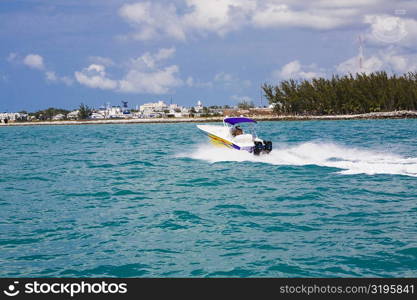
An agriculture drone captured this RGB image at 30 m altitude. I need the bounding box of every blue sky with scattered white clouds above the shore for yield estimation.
[0,0,417,112]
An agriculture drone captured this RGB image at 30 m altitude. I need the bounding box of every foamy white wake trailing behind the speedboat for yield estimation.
[181,142,417,177]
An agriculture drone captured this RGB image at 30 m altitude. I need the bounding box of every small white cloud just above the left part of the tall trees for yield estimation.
[272,60,325,80]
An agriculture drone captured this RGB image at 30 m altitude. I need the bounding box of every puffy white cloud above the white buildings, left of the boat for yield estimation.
[75,48,184,94]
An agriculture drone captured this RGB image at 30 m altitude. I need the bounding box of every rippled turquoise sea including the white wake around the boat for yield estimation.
[0,120,417,277]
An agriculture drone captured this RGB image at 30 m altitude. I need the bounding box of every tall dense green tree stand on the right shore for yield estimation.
[262,72,417,115]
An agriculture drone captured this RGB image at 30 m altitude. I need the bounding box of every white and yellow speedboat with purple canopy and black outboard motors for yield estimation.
[197,117,272,155]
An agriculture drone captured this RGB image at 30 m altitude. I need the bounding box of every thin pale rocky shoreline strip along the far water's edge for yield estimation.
[0,110,417,127]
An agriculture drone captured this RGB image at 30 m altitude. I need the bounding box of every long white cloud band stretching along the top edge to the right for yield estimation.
[119,0,417,41]
